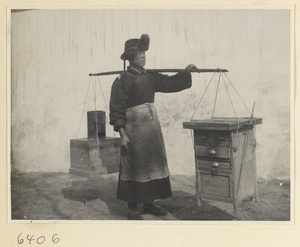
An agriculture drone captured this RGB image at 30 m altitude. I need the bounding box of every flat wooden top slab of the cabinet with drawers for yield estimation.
[183,117,262,131]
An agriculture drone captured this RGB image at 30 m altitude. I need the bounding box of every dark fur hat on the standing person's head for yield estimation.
[121,34,150,61]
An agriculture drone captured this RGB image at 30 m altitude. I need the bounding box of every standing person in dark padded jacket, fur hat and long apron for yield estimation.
[110,34,196,220]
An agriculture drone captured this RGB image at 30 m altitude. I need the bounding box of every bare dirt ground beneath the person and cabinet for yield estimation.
[11,173,290,221]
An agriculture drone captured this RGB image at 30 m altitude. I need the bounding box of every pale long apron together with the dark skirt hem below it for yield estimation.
[117,103,171,203]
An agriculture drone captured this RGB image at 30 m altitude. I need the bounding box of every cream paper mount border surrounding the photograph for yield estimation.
[0,1,299,246]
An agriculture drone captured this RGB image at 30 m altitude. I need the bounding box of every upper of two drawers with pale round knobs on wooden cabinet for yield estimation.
[195,146,230,159]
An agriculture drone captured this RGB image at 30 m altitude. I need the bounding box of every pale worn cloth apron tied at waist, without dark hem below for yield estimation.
[120,103,169,182]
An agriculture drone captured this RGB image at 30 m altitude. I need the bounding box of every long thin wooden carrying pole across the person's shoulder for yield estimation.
[89,69,228,76]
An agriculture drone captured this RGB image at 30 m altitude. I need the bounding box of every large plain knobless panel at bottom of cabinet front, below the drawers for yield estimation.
[199,172,232,198]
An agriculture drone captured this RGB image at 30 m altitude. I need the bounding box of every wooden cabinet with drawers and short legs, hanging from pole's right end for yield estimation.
[183,118,262,212]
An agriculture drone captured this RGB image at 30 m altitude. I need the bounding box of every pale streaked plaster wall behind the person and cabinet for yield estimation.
[11,9,291,178]
